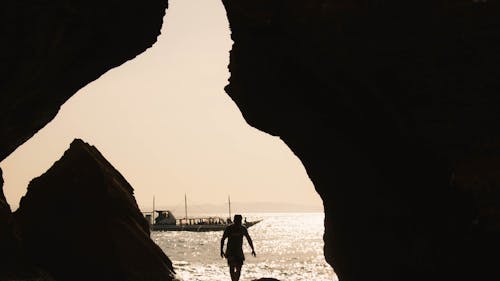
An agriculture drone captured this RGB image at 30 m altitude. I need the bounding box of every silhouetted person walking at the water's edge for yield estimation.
[220,215,255,281]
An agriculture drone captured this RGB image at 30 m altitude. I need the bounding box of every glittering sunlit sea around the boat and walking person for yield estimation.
[151,213,338,281]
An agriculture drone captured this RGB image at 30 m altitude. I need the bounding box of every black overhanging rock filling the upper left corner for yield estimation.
[0,0,168,160]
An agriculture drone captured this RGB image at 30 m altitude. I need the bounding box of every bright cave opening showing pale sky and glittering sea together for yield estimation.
[0,0,335,280]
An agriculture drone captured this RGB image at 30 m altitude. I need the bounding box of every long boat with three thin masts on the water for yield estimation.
[146,195,262,232]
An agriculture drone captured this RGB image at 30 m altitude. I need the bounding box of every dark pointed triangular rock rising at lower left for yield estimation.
[15,139,173,281]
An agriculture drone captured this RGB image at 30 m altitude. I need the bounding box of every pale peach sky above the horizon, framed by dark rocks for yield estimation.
[0,0,322,210]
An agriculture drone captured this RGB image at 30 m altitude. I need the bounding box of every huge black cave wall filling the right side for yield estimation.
[222,0,500,280]
